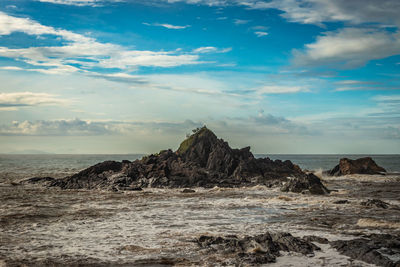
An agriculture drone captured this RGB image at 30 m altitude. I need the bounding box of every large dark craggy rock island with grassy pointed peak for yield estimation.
[39,127,329,194]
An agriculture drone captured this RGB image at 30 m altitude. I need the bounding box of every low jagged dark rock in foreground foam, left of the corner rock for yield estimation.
[196,232,319,265]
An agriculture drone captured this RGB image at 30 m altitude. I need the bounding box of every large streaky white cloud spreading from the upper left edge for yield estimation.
[0,12,203,74]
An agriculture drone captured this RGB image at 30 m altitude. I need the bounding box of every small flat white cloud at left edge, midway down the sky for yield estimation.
[0,92,67,109]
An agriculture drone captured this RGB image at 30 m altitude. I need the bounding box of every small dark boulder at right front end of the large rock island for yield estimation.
[281,173,330,195]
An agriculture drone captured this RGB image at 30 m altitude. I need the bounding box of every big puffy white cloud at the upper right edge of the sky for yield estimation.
[293,28,400,68]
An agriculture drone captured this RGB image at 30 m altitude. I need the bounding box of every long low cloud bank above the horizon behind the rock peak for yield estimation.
[0,115,311,136]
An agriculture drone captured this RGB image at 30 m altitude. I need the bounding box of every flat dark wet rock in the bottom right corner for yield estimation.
[331,234,400,267]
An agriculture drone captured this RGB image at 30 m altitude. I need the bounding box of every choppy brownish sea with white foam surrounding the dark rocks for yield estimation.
[0,154,400,267]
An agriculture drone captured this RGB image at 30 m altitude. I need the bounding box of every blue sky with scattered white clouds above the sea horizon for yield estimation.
[0,0,400,154]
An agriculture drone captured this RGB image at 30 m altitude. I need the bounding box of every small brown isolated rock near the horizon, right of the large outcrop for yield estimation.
[328,157,386,176]
